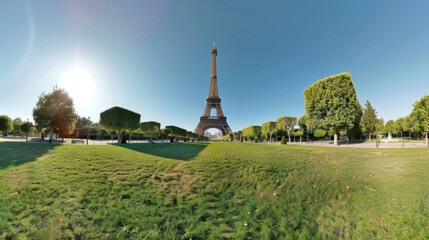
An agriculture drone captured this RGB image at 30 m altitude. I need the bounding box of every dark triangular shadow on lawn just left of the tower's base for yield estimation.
[115,143,209,161]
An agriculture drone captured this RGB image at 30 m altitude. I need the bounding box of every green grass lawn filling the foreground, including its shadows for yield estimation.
[0,142,429,239]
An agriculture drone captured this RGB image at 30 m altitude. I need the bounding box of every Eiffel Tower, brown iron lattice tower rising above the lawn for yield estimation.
[194,46,232,135]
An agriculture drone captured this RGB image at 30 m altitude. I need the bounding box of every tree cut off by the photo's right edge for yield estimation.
[411,95,429,147]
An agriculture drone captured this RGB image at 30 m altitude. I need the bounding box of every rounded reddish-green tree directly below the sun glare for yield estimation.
[33,87,77,142]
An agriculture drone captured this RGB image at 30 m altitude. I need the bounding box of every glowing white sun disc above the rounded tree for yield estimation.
[61,66,94,102]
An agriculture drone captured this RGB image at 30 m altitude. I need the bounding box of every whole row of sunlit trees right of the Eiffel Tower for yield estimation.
[231,73,429,146]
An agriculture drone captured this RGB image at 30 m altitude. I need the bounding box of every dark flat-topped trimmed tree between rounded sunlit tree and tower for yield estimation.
[100,106,140,143]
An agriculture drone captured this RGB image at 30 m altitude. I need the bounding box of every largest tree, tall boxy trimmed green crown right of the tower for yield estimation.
[304,73,362,146]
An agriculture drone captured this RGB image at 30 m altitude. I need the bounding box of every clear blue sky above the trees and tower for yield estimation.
[0,0,429,131]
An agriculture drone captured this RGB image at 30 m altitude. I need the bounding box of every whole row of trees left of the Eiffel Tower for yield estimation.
[0,87,200,143]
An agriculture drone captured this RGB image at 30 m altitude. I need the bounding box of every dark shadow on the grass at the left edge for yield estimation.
[0,142,58,170]
